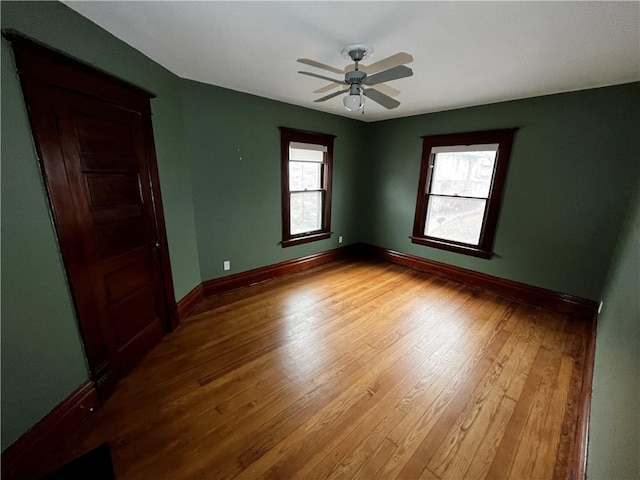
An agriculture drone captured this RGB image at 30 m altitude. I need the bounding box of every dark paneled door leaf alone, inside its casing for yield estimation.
[47,87,168,380]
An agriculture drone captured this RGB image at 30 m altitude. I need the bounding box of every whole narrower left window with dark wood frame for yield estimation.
[280,127,335,247]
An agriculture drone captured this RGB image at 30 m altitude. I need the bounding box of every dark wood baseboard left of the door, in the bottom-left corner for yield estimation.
[2,381,100,480]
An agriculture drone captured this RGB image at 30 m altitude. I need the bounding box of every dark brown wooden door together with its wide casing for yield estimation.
[8,31,175,395]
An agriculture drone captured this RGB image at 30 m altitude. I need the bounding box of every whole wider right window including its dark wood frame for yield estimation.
[411,129,515,258]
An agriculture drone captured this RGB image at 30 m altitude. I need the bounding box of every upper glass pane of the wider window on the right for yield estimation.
[431,150,496,198]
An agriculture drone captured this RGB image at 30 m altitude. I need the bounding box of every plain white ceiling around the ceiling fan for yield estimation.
[65,1,640,121]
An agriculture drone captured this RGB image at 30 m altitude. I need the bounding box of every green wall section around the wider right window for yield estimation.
[362,83,640,300]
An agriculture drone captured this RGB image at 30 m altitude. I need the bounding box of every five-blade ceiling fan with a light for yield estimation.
[298,45,413,112]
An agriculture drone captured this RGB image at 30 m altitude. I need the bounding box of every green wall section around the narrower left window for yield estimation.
[182,80,366,280]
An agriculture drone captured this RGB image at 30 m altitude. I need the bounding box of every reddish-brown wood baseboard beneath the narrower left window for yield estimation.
[202,244,362,297]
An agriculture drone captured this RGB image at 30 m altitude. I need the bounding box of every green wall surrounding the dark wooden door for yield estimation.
[0,1,201,449]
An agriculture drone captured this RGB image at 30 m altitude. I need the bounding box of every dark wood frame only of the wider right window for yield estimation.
[410,128,517,259]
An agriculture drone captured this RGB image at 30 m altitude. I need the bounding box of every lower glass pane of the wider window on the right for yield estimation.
[424,196,487,245]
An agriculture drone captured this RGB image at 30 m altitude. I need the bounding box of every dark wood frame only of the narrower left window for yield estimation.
[280,127,336,247]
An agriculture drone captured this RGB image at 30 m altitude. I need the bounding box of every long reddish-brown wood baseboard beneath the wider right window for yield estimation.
[364,245,598,321]
